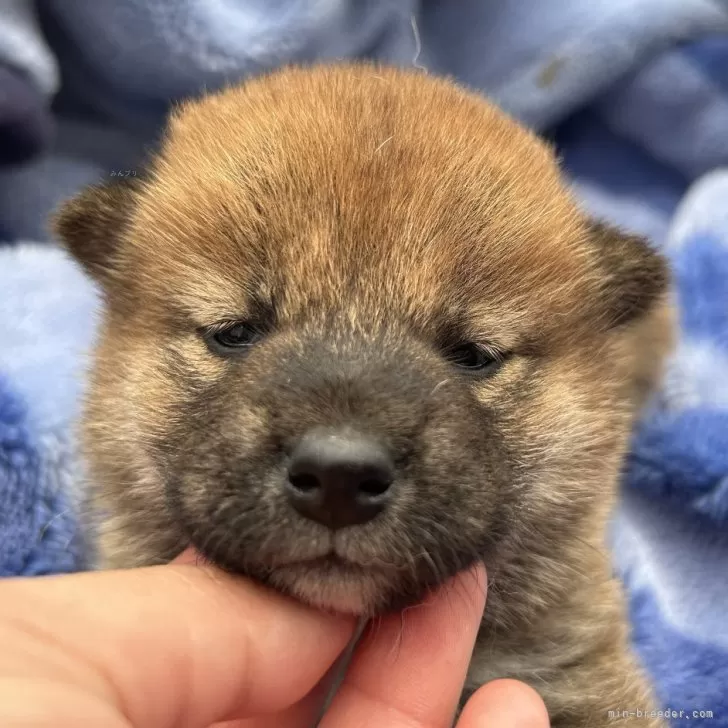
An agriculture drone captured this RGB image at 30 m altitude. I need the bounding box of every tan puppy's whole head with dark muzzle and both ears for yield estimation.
[57,66,666,613]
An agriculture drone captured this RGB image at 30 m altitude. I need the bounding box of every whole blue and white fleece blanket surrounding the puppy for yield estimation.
[0,0,728,727]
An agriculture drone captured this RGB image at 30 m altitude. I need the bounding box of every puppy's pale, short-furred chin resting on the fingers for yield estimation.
[268,564,393,617]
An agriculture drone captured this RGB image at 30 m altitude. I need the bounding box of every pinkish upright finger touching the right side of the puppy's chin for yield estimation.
[321,565,486,728]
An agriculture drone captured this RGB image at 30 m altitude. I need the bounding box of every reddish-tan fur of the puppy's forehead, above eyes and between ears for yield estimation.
[129,65,590,343]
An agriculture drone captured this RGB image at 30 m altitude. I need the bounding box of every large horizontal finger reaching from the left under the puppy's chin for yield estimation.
[0,565,353,728]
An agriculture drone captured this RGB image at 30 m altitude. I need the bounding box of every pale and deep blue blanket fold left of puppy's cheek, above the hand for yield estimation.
[0,245,98,576]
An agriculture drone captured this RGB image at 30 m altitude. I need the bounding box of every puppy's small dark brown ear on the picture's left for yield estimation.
[52,177,139,286]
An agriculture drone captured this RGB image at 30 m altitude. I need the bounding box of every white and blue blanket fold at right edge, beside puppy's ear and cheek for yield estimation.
[628,168,728,524]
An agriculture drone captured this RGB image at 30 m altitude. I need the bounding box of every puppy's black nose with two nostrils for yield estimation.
[287,430,394,529]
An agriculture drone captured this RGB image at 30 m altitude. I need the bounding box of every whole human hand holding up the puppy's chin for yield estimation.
[0,552,548,728]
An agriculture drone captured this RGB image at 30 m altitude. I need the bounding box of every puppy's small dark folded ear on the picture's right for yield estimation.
[589,222,670,328]
